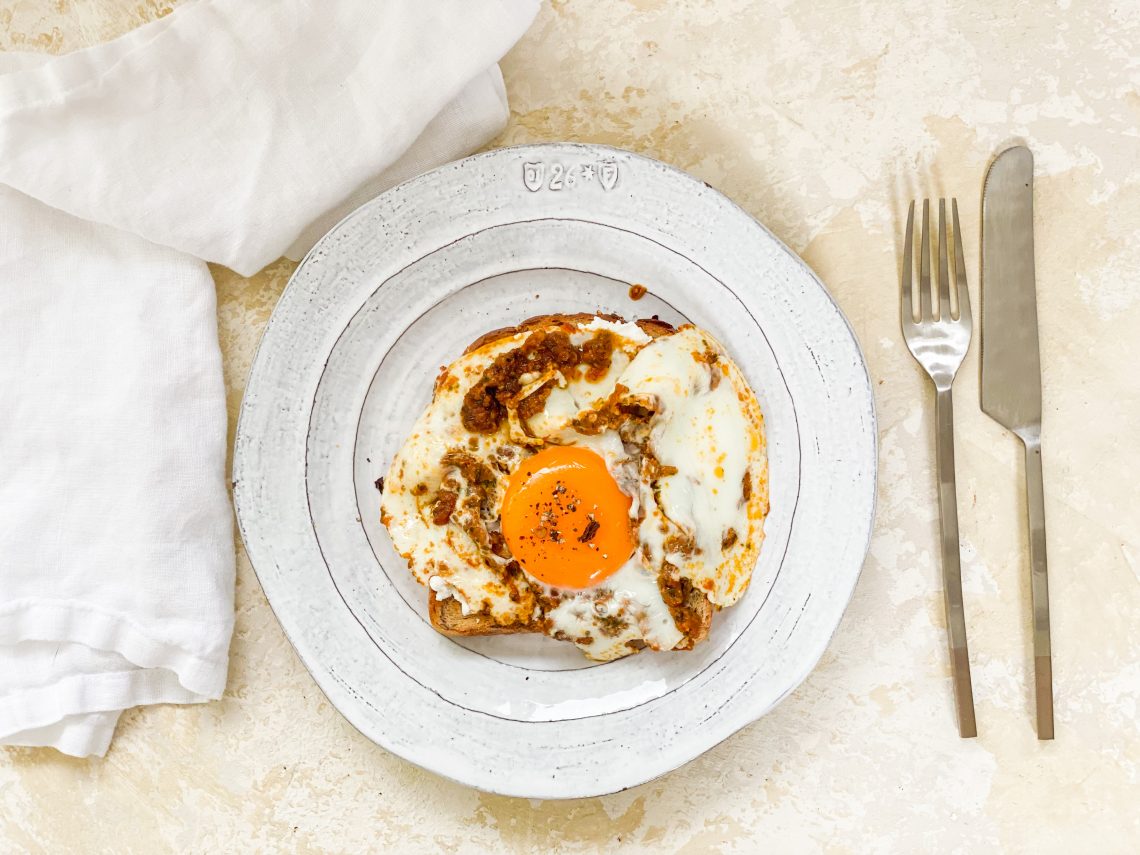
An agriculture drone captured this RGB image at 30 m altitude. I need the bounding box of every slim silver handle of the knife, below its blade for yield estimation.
[1023,434,1053,739]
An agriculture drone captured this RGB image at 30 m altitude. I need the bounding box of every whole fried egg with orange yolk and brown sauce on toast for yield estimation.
[382,315,767,660]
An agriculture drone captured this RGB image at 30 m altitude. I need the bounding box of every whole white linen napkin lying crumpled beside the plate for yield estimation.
[0,0,537,756]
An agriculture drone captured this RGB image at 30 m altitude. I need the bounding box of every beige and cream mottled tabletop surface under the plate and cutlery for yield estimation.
[0,0,1140,853]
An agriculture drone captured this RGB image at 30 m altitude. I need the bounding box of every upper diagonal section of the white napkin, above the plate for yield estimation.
[0,0,537,276]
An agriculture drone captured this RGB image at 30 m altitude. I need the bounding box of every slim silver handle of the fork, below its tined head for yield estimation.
[935,385,978,738]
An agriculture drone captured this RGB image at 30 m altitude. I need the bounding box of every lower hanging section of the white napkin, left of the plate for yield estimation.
[0,186,234,756]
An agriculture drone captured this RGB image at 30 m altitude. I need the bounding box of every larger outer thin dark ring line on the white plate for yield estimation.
[304,217,807,725]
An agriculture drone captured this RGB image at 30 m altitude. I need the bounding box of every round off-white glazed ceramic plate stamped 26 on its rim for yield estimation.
[234,144,876,798]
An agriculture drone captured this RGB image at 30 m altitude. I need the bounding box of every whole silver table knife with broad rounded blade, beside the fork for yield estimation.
[982,146,1053,739]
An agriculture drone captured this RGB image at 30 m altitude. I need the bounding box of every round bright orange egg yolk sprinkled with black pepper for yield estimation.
[502,446,634,588]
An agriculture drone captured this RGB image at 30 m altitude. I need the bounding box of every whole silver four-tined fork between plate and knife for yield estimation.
[899,200,978,738]
